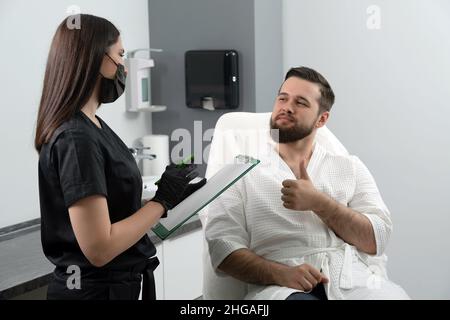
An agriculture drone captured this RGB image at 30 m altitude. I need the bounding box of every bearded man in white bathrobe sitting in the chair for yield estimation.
[205,67,408,300]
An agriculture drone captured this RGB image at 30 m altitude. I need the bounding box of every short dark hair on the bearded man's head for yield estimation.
[284,67,334,114]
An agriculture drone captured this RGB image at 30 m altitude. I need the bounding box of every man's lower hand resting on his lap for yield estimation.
[277,263,329,292]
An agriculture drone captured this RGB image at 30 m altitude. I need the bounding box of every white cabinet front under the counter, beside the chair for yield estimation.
[157,229,203,300]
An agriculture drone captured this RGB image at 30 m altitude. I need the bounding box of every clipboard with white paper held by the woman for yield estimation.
[152,155,260,240]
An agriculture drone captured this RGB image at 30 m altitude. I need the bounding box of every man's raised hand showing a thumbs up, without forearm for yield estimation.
[281,159,324,211]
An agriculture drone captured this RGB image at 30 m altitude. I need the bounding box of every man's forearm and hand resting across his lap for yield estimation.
[218,249,328,291]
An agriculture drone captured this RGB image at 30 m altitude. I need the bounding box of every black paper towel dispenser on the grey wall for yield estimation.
[184,50,239,110]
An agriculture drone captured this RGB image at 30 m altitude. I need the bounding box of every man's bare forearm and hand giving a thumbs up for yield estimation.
[281,160,377,254]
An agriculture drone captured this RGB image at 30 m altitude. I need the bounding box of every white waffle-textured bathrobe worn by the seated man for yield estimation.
[205,143,408,299]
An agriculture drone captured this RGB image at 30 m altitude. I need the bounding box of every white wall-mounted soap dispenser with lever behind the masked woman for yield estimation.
[125,48,166,112]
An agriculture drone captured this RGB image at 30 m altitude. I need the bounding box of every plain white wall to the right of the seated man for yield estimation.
[282,0,450,299]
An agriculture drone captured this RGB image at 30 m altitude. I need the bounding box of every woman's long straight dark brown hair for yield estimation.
[34,14,120,152]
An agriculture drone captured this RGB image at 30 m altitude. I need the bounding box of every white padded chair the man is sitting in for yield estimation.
[200,112,348,300]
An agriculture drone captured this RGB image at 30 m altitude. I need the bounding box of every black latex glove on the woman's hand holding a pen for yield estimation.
[151,164,206,218]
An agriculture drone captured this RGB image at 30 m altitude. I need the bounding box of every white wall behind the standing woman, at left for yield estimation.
[0,0,151,228]
